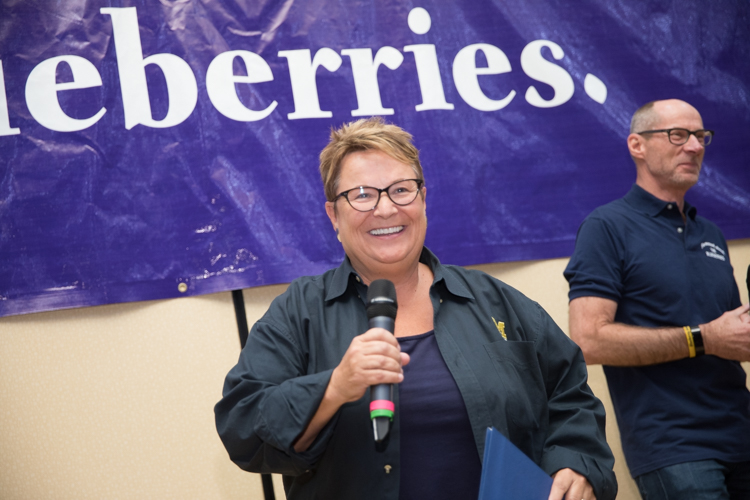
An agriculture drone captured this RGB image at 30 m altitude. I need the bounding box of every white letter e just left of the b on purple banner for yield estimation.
[26,55,107,132]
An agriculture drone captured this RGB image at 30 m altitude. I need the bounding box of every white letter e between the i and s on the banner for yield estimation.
[453,43,516,111]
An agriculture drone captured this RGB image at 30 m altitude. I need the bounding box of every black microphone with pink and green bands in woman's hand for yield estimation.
[367,280,398,445]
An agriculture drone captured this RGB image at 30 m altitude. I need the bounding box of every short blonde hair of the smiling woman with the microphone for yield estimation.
[320,117,424,201]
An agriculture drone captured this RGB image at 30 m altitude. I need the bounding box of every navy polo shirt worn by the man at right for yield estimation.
[565,185,750,477]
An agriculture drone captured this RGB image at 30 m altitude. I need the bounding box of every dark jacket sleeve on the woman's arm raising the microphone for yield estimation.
[214,295,337,476]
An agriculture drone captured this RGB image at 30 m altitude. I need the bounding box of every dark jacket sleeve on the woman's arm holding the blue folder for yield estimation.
[537,307,617,500]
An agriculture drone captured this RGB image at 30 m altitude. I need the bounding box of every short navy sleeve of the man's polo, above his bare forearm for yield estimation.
[563,217,624,302]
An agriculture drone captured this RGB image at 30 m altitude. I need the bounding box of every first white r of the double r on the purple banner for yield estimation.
[279,47,341,120]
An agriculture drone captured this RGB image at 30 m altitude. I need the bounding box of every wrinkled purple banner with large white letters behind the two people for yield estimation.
[0,0,750,316]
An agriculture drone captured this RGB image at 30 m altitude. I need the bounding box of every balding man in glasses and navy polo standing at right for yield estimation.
[565,100,750,500]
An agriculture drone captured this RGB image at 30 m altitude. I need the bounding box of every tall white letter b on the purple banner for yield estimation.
[99,7,198,130]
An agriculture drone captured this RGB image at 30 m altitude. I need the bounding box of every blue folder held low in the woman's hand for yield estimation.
[479,427,552,500]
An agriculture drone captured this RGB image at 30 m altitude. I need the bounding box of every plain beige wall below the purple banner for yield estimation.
[0,240,750,500]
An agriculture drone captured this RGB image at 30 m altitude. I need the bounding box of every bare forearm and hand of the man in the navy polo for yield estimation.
[570,297,750,366]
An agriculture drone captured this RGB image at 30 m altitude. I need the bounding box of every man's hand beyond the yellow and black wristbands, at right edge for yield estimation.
[700,304,750,361]
